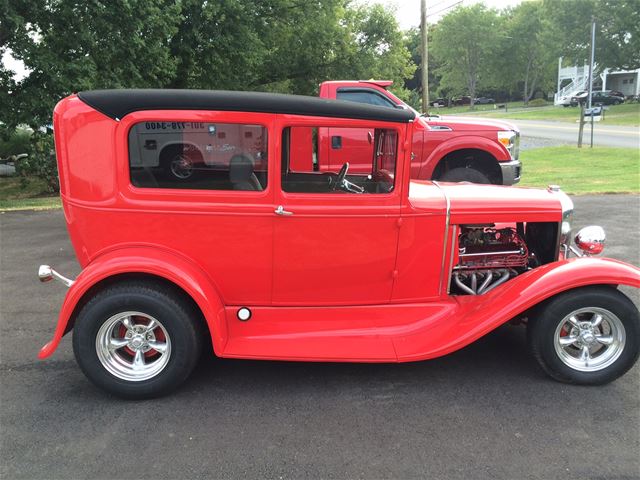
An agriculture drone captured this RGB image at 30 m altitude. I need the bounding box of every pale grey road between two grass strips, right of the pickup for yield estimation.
[507,119,640,148]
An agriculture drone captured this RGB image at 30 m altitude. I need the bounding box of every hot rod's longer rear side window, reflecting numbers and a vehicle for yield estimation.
[129,121,268,191]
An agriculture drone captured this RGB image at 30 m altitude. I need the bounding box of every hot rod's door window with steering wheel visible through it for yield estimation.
[282,126,398,194]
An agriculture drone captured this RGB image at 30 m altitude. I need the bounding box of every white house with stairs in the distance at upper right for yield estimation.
[554,58,640,105]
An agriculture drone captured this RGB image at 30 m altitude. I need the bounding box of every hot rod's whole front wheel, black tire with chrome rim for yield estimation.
[527,286,640,385]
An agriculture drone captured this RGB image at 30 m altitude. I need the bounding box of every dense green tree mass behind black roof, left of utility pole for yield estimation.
[0,0,415,129]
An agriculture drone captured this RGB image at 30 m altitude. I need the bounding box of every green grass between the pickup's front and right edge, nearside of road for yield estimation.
[518,146,640,194]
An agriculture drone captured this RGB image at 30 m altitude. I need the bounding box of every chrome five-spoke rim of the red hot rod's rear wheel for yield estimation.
[96,311,171,382]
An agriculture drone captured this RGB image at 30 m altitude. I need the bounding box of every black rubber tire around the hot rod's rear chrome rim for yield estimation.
[73,281,203,399]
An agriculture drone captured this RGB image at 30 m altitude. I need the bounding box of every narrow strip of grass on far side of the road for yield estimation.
[444,103,640,126]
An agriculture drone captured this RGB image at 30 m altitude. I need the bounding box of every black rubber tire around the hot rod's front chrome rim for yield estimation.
[527,286,640,385]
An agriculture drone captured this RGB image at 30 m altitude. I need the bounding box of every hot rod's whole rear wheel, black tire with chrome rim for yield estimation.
[73,282,202,399]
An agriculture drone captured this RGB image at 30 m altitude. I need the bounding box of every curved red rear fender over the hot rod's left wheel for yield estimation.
[38,246,227,359]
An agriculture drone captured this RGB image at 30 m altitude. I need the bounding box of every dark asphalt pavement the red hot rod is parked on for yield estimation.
[0,196,640,480]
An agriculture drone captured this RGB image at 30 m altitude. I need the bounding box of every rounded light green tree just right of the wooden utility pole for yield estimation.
[430,4,503,106]
